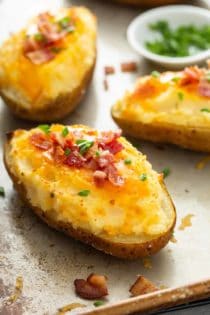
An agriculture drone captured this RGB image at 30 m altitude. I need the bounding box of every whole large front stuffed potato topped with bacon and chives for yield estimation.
[4,124,176,259]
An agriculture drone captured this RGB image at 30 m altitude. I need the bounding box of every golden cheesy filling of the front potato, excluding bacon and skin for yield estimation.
[6,125,174,241]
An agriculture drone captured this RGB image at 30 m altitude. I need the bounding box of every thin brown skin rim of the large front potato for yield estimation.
[4,132,176,260]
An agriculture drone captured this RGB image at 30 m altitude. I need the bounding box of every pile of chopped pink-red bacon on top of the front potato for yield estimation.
[30,130,124,186]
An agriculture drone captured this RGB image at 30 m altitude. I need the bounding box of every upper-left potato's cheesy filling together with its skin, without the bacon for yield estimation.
[0,7,96,121]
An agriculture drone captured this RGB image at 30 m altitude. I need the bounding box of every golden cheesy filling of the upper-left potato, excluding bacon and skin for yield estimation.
[0,7,96,108]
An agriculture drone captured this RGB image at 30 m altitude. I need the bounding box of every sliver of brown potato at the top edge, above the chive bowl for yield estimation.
[112,0,183,7]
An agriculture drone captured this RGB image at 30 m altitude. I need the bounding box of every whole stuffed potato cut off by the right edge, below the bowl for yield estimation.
[112,67,210,152]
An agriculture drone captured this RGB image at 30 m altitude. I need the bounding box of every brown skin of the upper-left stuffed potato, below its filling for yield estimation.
[0,58,96,122]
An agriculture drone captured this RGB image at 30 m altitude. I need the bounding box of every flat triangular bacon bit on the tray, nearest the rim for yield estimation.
[129,276,158,296]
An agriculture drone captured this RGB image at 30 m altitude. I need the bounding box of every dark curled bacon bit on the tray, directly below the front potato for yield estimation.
[74,274,108,300]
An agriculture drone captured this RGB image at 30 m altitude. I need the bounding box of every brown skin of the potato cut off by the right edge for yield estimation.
[112,114,210,152]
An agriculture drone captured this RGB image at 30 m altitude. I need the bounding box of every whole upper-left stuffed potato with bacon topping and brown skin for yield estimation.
[0,7,97,122]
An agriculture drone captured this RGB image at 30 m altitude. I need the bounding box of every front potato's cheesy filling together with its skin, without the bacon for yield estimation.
[4,125,176,259]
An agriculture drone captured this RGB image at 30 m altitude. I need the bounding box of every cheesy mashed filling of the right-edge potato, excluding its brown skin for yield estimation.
[113,72,210,126]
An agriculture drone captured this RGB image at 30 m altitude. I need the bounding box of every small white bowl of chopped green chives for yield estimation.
[127,5,210,69]
